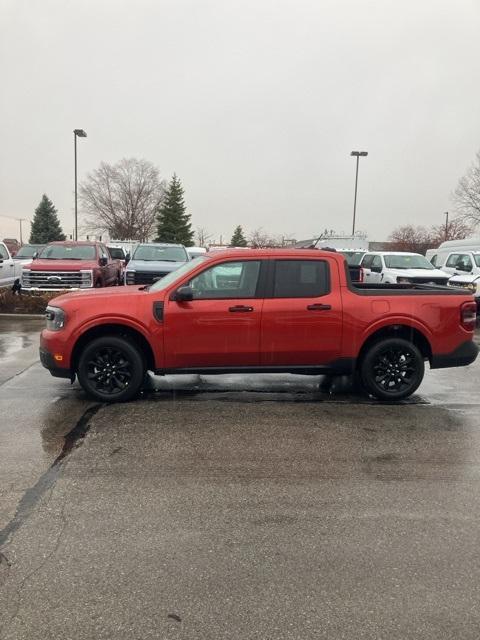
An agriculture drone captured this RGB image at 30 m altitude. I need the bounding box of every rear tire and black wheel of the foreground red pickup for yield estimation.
[360,338,425,400]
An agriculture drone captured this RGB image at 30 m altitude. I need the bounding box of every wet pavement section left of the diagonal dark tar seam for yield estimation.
[0,317,93,532]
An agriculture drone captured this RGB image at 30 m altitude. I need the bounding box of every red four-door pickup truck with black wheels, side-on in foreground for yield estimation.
[40,249,478,401]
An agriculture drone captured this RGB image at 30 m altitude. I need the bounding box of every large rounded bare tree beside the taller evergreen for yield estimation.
[79,158,165,241]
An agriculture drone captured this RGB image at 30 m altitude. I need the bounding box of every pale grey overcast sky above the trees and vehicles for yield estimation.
[0,0,480,240]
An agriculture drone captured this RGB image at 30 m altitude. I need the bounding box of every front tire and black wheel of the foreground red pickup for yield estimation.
[77,336,146,402]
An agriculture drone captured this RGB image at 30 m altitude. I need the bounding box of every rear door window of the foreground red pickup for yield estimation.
[273,260,330,298]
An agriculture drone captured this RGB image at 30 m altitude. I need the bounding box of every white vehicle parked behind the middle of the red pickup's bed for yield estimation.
[360,251,451,284]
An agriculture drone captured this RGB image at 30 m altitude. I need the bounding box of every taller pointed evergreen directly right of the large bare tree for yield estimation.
[156,173,194,247]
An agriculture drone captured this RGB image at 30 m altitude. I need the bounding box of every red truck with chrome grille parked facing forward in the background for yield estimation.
[21,241,123,291]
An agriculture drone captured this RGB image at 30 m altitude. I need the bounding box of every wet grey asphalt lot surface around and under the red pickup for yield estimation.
[0,318,480,640]
